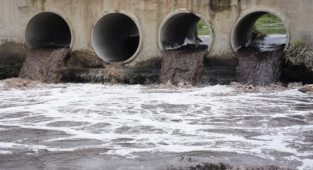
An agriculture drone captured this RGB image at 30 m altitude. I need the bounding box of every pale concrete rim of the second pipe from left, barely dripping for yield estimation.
[91,11,143,64]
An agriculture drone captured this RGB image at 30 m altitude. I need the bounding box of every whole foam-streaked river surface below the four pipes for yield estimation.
[0,82,313,170]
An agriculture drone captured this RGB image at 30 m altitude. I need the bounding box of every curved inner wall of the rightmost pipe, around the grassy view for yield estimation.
[231,11,289,52]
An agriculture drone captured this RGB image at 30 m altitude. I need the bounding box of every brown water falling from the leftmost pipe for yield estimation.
[19,47,69,83]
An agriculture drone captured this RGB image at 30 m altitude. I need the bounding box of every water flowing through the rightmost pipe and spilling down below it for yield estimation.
[237,34,287,86]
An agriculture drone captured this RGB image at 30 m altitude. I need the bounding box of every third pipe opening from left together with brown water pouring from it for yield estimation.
[160,13,210,85]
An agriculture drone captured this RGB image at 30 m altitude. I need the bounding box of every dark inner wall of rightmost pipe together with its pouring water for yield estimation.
[232,12,287,86]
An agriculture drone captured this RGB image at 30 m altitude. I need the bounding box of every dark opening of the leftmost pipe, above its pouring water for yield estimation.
[25,12,72,48]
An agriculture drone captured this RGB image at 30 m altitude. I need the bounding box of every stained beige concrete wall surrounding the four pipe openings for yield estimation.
[0,0,313,67]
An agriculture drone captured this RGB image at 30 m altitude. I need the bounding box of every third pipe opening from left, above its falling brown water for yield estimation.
[159,12,211,50]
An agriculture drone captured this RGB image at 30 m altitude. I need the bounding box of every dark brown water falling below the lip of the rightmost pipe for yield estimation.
[237,45,285,86]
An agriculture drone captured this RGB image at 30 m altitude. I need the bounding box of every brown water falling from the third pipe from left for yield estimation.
[160,45,208,85]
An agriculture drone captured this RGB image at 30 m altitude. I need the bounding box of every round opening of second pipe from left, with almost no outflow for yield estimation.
[92,13,141,63]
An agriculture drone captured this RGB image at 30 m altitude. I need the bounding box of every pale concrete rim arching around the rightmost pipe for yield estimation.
[230,9,290,53]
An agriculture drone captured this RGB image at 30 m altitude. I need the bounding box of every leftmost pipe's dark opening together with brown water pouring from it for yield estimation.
[19,12,71,83]
